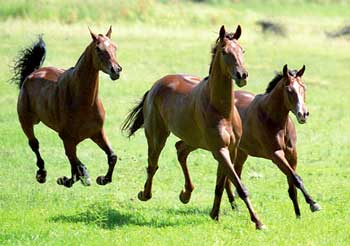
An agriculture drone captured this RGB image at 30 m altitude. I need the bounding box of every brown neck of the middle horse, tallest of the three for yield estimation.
[207,52,234,119]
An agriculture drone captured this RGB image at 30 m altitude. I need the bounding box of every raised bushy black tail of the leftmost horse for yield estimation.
[11,35,46,89]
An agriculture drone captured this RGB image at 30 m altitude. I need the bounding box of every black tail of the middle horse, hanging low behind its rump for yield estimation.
[122,91,149,137]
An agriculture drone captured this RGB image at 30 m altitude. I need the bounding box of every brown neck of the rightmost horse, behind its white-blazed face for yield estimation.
[261,81,289,126]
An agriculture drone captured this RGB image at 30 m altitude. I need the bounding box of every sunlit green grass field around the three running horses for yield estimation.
[0,0,350,245]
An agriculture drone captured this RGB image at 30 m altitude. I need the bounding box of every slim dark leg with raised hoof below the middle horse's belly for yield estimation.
[175,141,194,204]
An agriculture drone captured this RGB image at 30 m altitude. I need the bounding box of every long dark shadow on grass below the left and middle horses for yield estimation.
[49,201,210,229]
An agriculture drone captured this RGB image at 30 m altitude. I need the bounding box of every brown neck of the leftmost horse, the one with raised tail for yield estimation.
[70,45,99,106]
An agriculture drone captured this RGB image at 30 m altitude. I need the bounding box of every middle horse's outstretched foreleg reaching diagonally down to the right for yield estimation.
[213,148,264,229]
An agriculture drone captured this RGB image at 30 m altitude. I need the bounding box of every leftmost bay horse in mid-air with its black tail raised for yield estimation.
[12,27,122,187]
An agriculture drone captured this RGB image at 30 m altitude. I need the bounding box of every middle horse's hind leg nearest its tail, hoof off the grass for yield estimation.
[138,120,170,201]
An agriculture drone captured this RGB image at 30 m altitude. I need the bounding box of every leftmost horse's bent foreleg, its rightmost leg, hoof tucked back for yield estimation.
[91,129,117,185]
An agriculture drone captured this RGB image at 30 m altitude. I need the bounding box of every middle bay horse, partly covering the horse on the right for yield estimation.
[122,26,263,229]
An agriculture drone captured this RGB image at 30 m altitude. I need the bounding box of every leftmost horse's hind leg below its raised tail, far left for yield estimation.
[19,111,47,184]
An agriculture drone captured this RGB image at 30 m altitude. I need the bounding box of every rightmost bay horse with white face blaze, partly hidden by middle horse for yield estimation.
[174,65,321,217]
